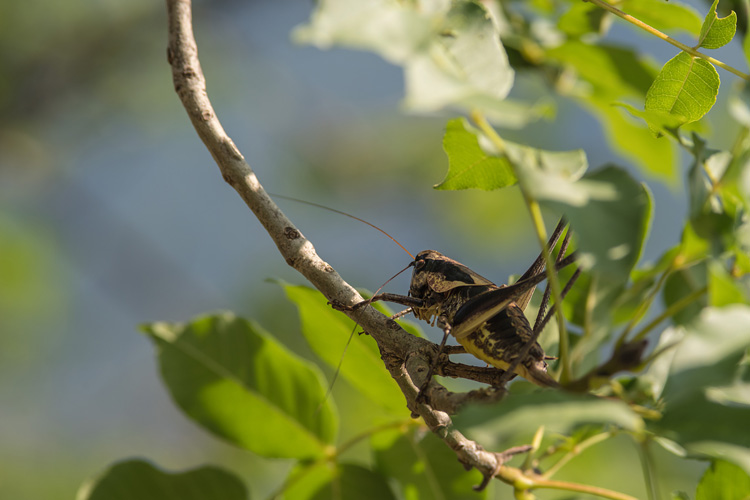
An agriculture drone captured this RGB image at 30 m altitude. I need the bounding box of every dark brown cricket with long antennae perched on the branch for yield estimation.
[279,196,580,392]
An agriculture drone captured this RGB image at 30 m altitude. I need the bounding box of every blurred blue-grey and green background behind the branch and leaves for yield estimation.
[0,0,745,500]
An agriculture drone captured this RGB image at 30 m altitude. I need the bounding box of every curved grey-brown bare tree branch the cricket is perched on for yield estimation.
[166,0,624,494]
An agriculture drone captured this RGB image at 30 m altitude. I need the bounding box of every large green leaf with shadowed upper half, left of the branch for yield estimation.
[142,313,338,458]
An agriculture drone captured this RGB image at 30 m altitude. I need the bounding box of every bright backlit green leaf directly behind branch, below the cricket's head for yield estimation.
[284,285,412,415]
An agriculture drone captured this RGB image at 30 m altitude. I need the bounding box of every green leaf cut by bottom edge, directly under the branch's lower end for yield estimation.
[371,428,487,500]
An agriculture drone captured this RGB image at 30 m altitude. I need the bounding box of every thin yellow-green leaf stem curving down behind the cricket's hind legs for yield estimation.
[471,109,572,384]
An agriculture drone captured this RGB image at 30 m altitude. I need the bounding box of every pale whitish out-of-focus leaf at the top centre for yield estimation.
[294,0,514,112]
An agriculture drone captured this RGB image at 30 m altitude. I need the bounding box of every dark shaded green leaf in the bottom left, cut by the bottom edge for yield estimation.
[76,460,250,500]
